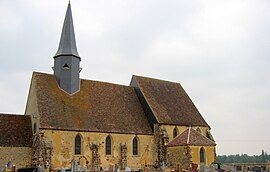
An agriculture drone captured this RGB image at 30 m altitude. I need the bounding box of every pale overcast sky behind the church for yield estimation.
[0,0,270,155]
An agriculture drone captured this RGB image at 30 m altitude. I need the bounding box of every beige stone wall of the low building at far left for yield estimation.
[0,147,32,169]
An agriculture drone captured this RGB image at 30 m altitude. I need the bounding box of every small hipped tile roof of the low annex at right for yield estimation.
[167,128,216,147]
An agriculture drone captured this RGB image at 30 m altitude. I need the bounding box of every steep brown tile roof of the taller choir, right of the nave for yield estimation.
[133,76,209,127]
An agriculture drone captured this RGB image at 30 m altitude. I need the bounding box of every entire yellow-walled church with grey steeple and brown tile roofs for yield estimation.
[0,3,216,171]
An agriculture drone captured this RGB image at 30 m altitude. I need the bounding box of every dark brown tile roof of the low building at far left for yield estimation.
[0,114,32,147]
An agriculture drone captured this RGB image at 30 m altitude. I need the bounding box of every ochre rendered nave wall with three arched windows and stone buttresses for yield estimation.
[42,130,156,170]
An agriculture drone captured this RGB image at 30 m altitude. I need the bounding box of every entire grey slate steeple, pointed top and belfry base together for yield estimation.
[53,3,81,94]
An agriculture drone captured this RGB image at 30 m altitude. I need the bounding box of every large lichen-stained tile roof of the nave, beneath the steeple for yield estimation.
[32,72,153,134]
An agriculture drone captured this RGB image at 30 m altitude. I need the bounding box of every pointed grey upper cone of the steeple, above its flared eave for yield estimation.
[54,1,81,59]
